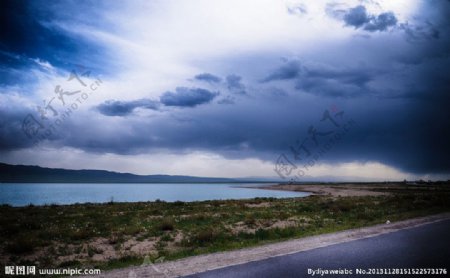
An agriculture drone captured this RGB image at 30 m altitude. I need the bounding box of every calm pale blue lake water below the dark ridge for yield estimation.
[0,183,309,206]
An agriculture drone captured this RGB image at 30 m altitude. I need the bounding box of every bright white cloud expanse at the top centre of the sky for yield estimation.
[39,0,351,100]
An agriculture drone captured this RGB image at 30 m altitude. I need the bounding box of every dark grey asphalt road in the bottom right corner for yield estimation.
[186,220,450,278]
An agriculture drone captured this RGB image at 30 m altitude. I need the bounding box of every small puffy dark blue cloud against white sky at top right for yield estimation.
[327,5,397,32]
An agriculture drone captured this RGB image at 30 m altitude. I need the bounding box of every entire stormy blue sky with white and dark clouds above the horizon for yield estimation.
[0,0,450,181]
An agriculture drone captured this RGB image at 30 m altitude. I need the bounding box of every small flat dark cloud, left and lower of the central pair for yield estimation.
[97,99,159,116]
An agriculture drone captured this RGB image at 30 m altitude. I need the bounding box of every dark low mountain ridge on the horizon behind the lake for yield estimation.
[0,163,253,183]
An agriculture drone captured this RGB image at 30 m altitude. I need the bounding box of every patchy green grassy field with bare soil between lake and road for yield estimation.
[0,182,450,269]
